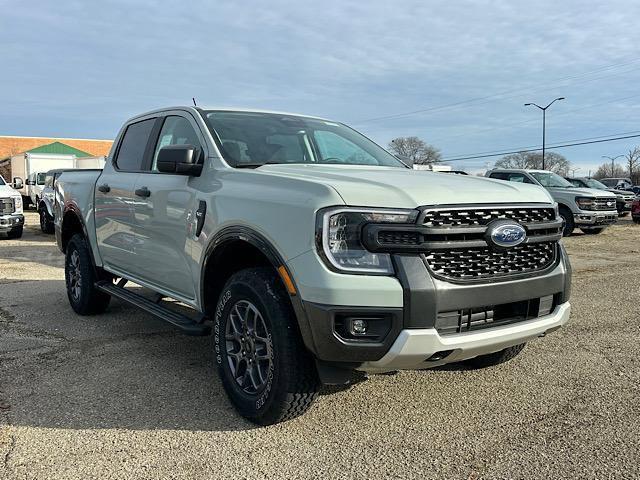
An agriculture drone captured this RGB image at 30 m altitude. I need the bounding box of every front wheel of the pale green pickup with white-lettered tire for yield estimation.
[214,268,319,425]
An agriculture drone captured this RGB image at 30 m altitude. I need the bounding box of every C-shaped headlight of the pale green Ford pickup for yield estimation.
[317,207,418,275]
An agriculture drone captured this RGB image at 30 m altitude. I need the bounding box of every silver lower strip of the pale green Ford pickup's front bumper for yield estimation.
[358,302,571,372]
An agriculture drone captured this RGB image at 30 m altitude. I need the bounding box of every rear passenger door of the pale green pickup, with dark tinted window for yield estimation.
[95,117,157,276]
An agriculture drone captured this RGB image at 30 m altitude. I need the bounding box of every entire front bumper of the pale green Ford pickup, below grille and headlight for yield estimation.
[293,246,571,371]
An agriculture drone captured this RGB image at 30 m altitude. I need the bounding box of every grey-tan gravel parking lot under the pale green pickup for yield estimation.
[0,212,640,479]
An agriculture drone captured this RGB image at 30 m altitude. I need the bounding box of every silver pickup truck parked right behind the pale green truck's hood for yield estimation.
[486,169,618,236]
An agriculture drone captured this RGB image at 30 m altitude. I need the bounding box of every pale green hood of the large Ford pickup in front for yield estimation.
[257,164,553,208]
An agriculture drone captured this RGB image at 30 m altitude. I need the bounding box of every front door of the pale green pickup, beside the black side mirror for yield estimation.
[135,111,206,300]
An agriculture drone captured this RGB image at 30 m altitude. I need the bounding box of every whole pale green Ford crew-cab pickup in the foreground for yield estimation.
[55,107,571,424]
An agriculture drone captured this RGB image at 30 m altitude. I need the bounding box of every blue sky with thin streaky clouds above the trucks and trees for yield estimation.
[0,0,640,175]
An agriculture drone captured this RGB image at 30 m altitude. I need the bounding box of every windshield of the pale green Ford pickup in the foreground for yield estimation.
[204,111,406,168]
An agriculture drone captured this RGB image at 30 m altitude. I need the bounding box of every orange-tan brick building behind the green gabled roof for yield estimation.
[0,136,113,179]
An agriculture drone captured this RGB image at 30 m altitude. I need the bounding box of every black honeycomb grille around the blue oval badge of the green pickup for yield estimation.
[363,204,562,282]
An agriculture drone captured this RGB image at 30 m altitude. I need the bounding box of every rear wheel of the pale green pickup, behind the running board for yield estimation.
[64,233,111,315]
